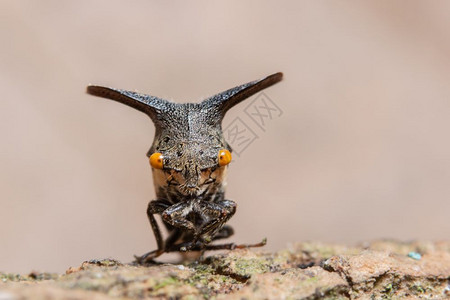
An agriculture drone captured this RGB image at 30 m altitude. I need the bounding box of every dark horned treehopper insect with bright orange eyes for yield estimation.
[87,73,283,263]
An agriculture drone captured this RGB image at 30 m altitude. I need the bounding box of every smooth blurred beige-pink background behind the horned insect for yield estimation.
[0,0,450,272]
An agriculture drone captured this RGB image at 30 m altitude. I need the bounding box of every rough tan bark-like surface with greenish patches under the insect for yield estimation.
[0,241,450,300]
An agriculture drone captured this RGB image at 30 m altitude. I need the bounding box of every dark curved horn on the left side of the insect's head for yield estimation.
[86,85,171,121]
